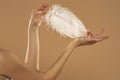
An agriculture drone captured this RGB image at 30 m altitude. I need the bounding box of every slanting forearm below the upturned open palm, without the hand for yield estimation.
[46,41,76,79]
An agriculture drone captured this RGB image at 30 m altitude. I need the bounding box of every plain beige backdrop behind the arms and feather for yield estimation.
[0,0,120,80]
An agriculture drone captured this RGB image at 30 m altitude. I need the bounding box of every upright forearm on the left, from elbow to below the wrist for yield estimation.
[25,25,39,70]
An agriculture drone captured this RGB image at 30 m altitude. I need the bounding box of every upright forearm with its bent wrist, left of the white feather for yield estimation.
[25,11,43,70]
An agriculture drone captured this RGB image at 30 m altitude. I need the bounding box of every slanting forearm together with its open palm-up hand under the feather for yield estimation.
[46,36,108,80]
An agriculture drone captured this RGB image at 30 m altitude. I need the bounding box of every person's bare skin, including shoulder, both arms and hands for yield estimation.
[0,4,108,80]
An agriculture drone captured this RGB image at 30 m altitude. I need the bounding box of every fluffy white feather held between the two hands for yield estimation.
[45,5,87,38]
